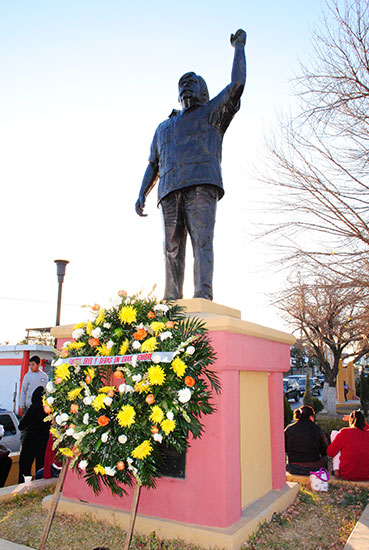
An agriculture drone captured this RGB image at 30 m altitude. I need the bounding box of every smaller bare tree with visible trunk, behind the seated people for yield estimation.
[275,273,369,414]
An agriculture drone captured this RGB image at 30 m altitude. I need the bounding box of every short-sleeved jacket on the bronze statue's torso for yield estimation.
[149,85,240,206]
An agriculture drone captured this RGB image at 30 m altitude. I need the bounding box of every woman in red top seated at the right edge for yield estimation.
[327,411,369,481]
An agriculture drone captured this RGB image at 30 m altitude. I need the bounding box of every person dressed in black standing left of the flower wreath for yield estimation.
[18,386,50,483]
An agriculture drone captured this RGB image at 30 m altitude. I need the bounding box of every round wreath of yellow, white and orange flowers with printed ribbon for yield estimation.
[44,291,220,495]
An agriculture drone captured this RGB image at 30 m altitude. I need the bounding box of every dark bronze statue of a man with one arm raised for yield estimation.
[136,29,246,300]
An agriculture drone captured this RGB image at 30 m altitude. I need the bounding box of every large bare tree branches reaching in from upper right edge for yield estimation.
[262,0,369,278]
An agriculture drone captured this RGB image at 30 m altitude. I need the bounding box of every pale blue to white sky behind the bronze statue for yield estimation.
[0,0,330,343]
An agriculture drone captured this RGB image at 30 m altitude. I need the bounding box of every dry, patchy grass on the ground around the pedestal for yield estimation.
[0,485,369,550]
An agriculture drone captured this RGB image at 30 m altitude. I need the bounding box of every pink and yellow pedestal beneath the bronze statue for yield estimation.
[49,298,297,548]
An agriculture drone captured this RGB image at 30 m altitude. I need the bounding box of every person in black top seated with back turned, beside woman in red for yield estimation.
[284,405,328,475]
